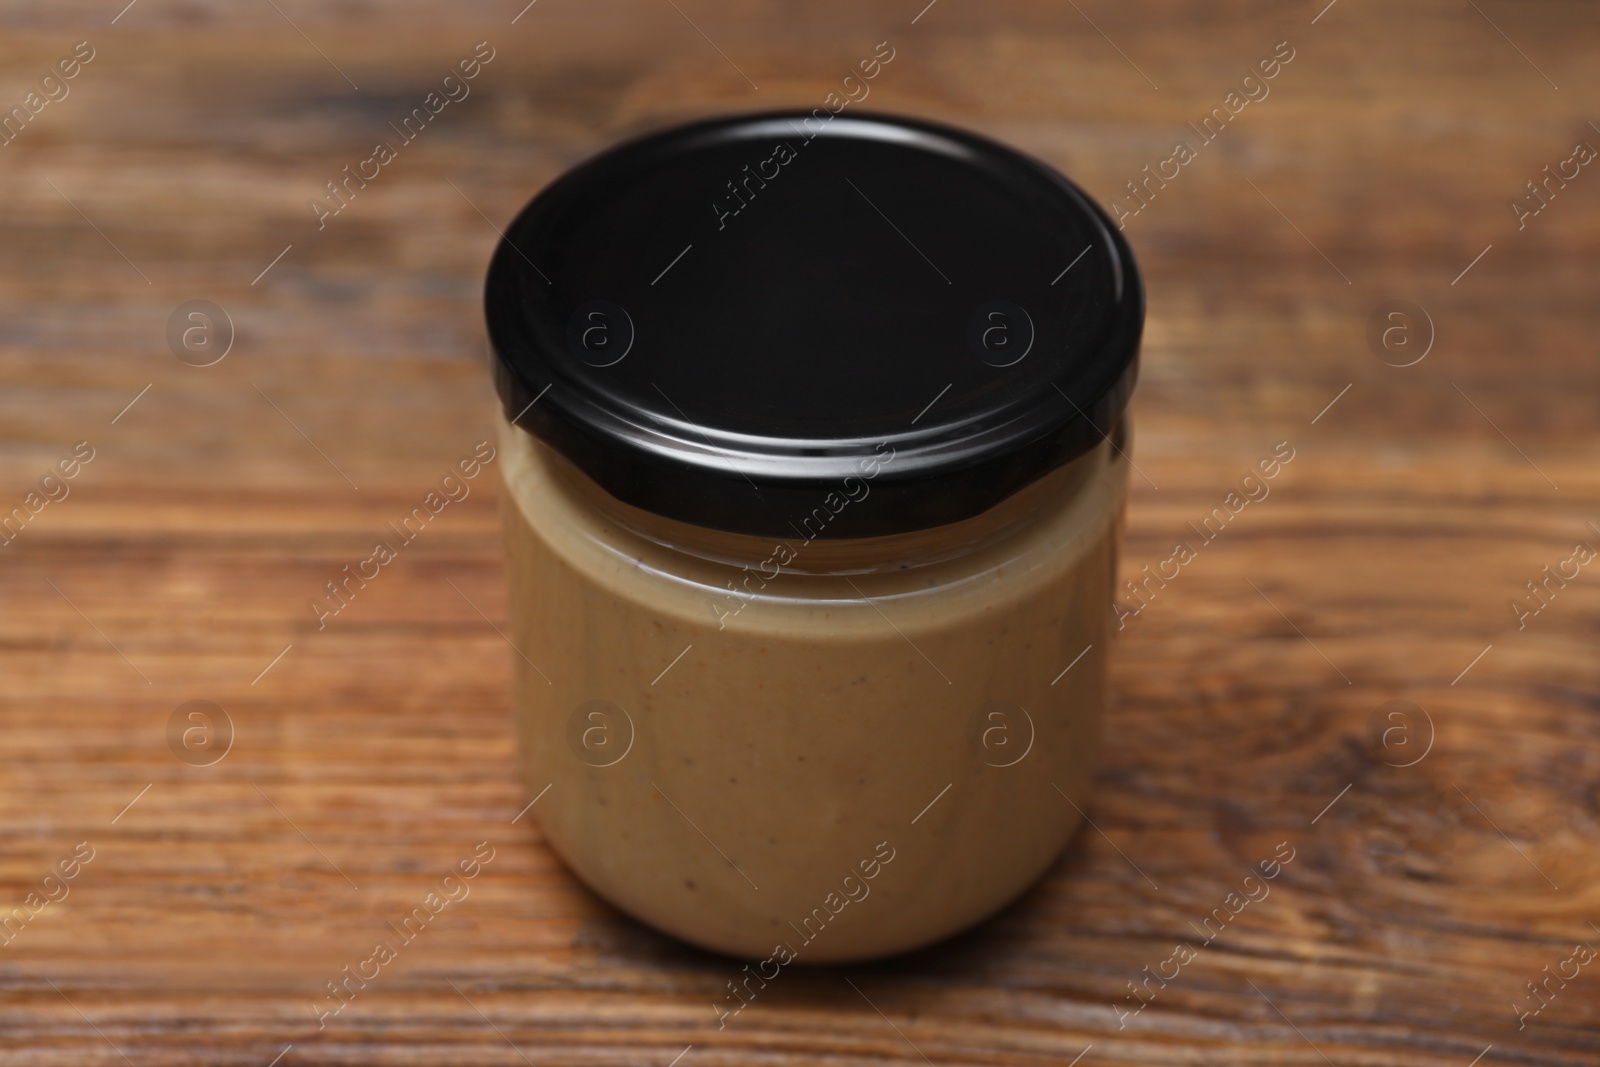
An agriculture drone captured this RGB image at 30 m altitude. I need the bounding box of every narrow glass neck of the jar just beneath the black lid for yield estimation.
[531,426,1125,576]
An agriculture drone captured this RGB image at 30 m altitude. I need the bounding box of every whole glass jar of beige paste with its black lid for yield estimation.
[486,112,1144,963]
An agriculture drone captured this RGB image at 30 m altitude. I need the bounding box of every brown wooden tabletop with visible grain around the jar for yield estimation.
[0,0,1600,1067]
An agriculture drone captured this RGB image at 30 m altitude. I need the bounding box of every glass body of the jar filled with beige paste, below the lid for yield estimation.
[501,422,1128,963]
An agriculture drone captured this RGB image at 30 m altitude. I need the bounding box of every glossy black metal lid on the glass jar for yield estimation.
[485,109,1144,537]
